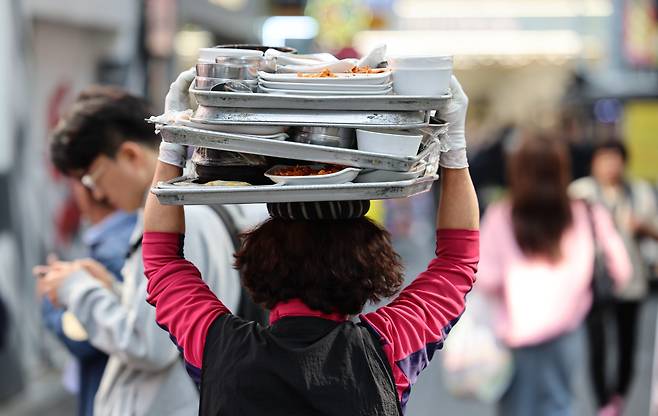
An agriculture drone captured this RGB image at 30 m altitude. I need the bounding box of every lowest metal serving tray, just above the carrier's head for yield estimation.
[151,174,438,205]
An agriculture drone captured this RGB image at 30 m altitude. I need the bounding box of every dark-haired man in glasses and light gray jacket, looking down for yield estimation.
[38,87,247,416]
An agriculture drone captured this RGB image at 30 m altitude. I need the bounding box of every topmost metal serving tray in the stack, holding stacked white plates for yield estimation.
[190,88,452,111]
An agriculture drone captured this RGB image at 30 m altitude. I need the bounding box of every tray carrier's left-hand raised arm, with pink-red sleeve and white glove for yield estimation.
[142,67,229,381]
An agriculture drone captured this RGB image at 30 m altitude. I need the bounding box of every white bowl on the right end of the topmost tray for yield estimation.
[393,68,452,96]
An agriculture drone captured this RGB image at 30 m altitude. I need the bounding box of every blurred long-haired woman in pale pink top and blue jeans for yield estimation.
[477,133,631,416]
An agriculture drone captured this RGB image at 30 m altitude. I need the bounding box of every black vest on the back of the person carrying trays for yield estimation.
[199,314,401,416]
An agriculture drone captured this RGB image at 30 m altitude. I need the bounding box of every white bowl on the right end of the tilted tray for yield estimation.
[356,129,423,157]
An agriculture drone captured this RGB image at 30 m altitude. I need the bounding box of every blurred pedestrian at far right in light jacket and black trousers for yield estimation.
[569,140,658,415]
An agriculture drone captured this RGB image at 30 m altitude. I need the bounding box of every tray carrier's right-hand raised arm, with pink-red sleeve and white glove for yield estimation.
[361,79,479,406]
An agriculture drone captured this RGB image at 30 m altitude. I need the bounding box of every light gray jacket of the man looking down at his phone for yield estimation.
[58,206,245,416]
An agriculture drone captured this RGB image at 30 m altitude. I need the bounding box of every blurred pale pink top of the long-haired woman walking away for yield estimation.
[477,202,632,347]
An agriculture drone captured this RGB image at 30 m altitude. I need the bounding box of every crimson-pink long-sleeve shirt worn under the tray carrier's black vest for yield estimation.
[143,230,479,407]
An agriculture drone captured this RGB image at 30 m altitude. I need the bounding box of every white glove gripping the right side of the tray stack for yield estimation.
[436,75,468,169]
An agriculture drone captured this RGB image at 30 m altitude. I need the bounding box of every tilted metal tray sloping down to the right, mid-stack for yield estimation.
[160,126,446,172]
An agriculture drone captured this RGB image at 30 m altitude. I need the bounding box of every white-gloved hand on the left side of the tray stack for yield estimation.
[158,68,196,168]
